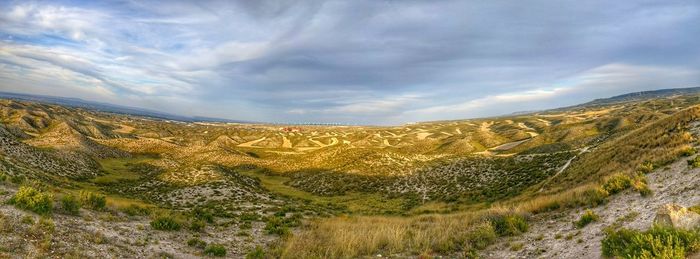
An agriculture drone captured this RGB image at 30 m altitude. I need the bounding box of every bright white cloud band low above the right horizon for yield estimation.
[404,63,700,123]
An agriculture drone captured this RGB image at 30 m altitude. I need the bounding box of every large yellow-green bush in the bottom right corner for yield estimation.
[601,226,700,258]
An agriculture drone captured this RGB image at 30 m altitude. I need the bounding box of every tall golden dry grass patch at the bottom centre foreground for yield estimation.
[279,208,519,258]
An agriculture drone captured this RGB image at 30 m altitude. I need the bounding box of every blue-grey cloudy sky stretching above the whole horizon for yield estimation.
[0,0,700,125]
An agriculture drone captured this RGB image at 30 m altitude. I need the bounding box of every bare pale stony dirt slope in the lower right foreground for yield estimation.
[482,149,700,258]
